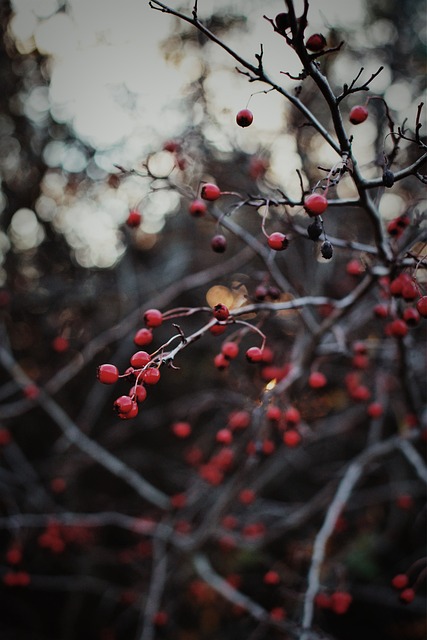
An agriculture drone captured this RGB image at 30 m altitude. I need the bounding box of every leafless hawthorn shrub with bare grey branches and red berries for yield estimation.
[0,0,427,640]
